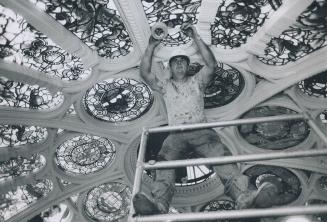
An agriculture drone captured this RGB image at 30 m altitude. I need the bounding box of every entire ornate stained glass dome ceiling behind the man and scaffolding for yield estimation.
[0,0,327,222]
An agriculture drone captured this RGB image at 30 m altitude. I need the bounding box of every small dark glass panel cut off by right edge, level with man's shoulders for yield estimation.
[298,71,327,98]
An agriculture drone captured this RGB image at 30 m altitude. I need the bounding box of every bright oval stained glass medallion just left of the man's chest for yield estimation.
[84,78,153,122]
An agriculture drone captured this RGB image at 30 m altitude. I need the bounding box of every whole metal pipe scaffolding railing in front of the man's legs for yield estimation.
[128,113,327,222]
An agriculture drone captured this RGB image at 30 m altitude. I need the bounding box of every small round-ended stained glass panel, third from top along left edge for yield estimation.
[0,125,48,148]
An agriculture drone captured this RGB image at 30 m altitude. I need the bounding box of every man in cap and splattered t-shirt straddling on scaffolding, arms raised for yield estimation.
[133,24,276,215]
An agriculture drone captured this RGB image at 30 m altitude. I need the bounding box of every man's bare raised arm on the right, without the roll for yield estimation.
[181,24,217,85]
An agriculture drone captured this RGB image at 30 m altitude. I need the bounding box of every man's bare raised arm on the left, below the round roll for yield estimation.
[140,36,160,91]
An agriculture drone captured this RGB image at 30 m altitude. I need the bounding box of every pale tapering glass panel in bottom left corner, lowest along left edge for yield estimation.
[0,179,53,221]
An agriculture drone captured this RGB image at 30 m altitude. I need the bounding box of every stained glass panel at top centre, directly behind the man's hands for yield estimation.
[142,0,202,46]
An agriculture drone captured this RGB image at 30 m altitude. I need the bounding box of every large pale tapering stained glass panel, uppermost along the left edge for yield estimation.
[0,5,91,81]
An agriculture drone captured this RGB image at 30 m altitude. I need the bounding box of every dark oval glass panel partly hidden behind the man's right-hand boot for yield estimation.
[244,165,302,206]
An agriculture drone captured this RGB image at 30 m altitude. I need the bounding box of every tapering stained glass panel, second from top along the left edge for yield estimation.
[0,76,64,110]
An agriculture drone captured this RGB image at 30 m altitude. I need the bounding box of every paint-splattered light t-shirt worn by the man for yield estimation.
[160,72,206,125]
